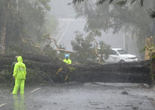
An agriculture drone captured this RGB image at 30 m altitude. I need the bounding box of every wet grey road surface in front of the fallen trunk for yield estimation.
[0,83,155,110]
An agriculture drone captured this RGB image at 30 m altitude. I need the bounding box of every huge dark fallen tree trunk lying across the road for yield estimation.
[0,55,151,84]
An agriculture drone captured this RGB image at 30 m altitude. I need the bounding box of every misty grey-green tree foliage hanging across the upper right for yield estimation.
[75,0,155,56]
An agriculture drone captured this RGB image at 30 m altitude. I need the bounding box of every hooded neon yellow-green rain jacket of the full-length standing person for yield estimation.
[13,56,26,80]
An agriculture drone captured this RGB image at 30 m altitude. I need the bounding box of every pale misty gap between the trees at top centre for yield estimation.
[51,0,86,50]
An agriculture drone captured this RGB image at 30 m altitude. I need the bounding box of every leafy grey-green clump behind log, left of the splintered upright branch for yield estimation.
[71,33,96,63]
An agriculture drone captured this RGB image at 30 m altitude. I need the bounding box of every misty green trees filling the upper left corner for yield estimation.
[0,0,57,54]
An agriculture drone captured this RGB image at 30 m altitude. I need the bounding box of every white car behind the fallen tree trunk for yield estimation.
[105,48,138,63]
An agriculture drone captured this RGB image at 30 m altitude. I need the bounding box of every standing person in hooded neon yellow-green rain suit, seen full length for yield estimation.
[12,56,26,95]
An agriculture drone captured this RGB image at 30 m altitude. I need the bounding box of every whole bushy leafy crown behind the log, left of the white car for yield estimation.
[71,30,110,64]
